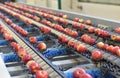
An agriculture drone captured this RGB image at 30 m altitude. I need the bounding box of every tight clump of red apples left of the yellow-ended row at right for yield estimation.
[81,34,96,45]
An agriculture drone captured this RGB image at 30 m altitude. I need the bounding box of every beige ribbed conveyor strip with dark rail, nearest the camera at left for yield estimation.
[0,21,65,78]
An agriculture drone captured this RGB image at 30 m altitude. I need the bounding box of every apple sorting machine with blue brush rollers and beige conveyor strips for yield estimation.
[0,3,120,78]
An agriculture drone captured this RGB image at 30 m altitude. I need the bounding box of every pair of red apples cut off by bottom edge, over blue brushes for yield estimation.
[73,68,93,78]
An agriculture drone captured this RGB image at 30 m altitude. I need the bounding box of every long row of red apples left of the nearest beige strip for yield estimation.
[0,26,48,78]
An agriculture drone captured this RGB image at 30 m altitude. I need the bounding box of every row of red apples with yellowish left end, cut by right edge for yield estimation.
[97,42,120,56]
